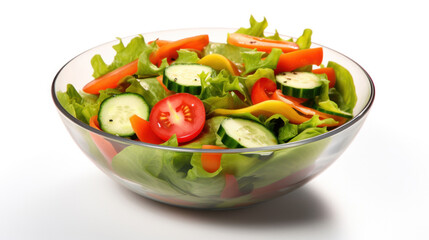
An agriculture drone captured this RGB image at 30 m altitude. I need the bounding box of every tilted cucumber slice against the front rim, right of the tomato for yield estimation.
[217,118,278,148]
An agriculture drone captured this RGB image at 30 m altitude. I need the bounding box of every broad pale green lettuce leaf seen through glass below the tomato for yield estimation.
[112,136,225,201]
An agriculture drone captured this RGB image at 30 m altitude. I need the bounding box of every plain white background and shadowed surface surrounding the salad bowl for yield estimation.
[0,0,429,240]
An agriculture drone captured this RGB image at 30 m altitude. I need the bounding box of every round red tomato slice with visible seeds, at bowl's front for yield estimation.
[149,93,206,143]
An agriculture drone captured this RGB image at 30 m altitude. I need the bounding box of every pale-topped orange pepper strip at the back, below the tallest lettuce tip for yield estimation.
[227,33,299,53]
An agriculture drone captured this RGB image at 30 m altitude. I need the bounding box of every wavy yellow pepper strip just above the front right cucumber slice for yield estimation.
[211,100,310,124]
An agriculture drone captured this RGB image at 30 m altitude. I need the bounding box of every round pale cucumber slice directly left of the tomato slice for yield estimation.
[98,93,149,137]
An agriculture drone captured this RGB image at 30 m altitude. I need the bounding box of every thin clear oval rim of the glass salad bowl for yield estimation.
[51,28,375,154]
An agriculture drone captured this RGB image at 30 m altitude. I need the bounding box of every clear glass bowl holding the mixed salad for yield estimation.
[52,28,375,209]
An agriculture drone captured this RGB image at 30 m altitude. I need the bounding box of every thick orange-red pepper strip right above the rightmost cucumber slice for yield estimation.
[275,47,323,73]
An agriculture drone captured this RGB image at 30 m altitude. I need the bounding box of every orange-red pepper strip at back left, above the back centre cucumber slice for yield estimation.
[149,35,209,66]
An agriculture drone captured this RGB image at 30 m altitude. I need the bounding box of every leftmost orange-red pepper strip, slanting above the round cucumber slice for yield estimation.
[82,60,138,94]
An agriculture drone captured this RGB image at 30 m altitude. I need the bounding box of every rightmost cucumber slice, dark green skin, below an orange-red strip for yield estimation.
[276,72,322,98]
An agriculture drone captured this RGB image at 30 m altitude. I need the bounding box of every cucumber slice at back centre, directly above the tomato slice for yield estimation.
[162,63,214,95]
